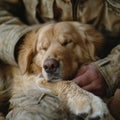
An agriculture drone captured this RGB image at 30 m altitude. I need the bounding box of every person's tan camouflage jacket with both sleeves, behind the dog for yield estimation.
[0,0,120,95]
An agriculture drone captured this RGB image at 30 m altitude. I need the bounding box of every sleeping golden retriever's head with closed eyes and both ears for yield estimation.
[18,22,104,80]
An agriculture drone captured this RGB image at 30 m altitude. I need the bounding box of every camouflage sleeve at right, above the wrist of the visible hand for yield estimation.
[95,44,120,96]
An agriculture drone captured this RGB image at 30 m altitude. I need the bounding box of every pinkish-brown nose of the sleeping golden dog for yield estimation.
[43,58,59,74]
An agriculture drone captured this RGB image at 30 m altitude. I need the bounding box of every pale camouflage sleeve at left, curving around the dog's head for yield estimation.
[0,2,38,65]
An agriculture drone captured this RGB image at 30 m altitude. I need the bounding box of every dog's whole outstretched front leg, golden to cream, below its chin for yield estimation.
[39,80,112,120]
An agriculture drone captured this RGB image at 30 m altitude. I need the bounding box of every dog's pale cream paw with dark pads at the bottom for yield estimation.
[68,94,109,120]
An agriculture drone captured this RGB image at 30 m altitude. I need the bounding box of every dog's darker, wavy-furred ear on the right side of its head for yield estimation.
[75,23,105,61]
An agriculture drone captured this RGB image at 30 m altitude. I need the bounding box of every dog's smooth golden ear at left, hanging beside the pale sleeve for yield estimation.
[18,30,38,74]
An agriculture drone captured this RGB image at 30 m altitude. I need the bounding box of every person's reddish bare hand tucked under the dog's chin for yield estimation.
[73,64,107,97]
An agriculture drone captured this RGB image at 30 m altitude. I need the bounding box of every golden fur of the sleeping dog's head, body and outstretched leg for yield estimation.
[0,22,113,120]
